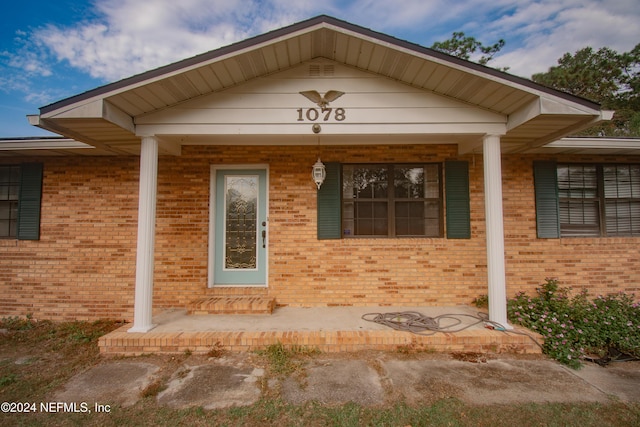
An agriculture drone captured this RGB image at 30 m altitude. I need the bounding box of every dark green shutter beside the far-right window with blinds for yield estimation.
[533,161,560,239]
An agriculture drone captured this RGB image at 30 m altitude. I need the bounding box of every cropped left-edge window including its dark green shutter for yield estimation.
[0,163,42,240]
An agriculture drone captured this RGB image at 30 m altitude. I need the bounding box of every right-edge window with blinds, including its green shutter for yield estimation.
[534,162,640,238]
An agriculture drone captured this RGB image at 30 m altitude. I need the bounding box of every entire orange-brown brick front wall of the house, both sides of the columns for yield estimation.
[0,145,640,320]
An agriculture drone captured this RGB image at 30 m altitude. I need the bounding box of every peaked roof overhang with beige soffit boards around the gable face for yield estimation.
[29,16,603,154]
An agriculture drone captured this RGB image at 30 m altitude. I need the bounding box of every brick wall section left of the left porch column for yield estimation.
[0,157,139,320]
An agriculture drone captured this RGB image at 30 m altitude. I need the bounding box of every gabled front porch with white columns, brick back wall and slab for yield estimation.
[30,16,610,340]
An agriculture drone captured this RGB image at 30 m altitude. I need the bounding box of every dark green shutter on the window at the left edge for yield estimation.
[16,163,42,240]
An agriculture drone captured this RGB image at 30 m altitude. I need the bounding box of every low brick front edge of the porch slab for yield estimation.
[98,325,542,356]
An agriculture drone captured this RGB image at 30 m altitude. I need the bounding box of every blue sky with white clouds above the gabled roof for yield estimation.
[0,0,640,138]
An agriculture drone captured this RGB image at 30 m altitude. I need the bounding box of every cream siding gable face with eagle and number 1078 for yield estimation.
[135,60,507,144]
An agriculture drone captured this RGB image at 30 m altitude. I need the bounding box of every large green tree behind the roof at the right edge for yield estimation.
[532,44,640,136]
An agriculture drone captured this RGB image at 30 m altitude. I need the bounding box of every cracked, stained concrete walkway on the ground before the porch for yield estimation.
[52,352,640,409]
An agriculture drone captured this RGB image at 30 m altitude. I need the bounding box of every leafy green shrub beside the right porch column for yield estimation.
[507,279,640,368]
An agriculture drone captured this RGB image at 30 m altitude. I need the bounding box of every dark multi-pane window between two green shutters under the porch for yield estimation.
[342,164,443,237]
